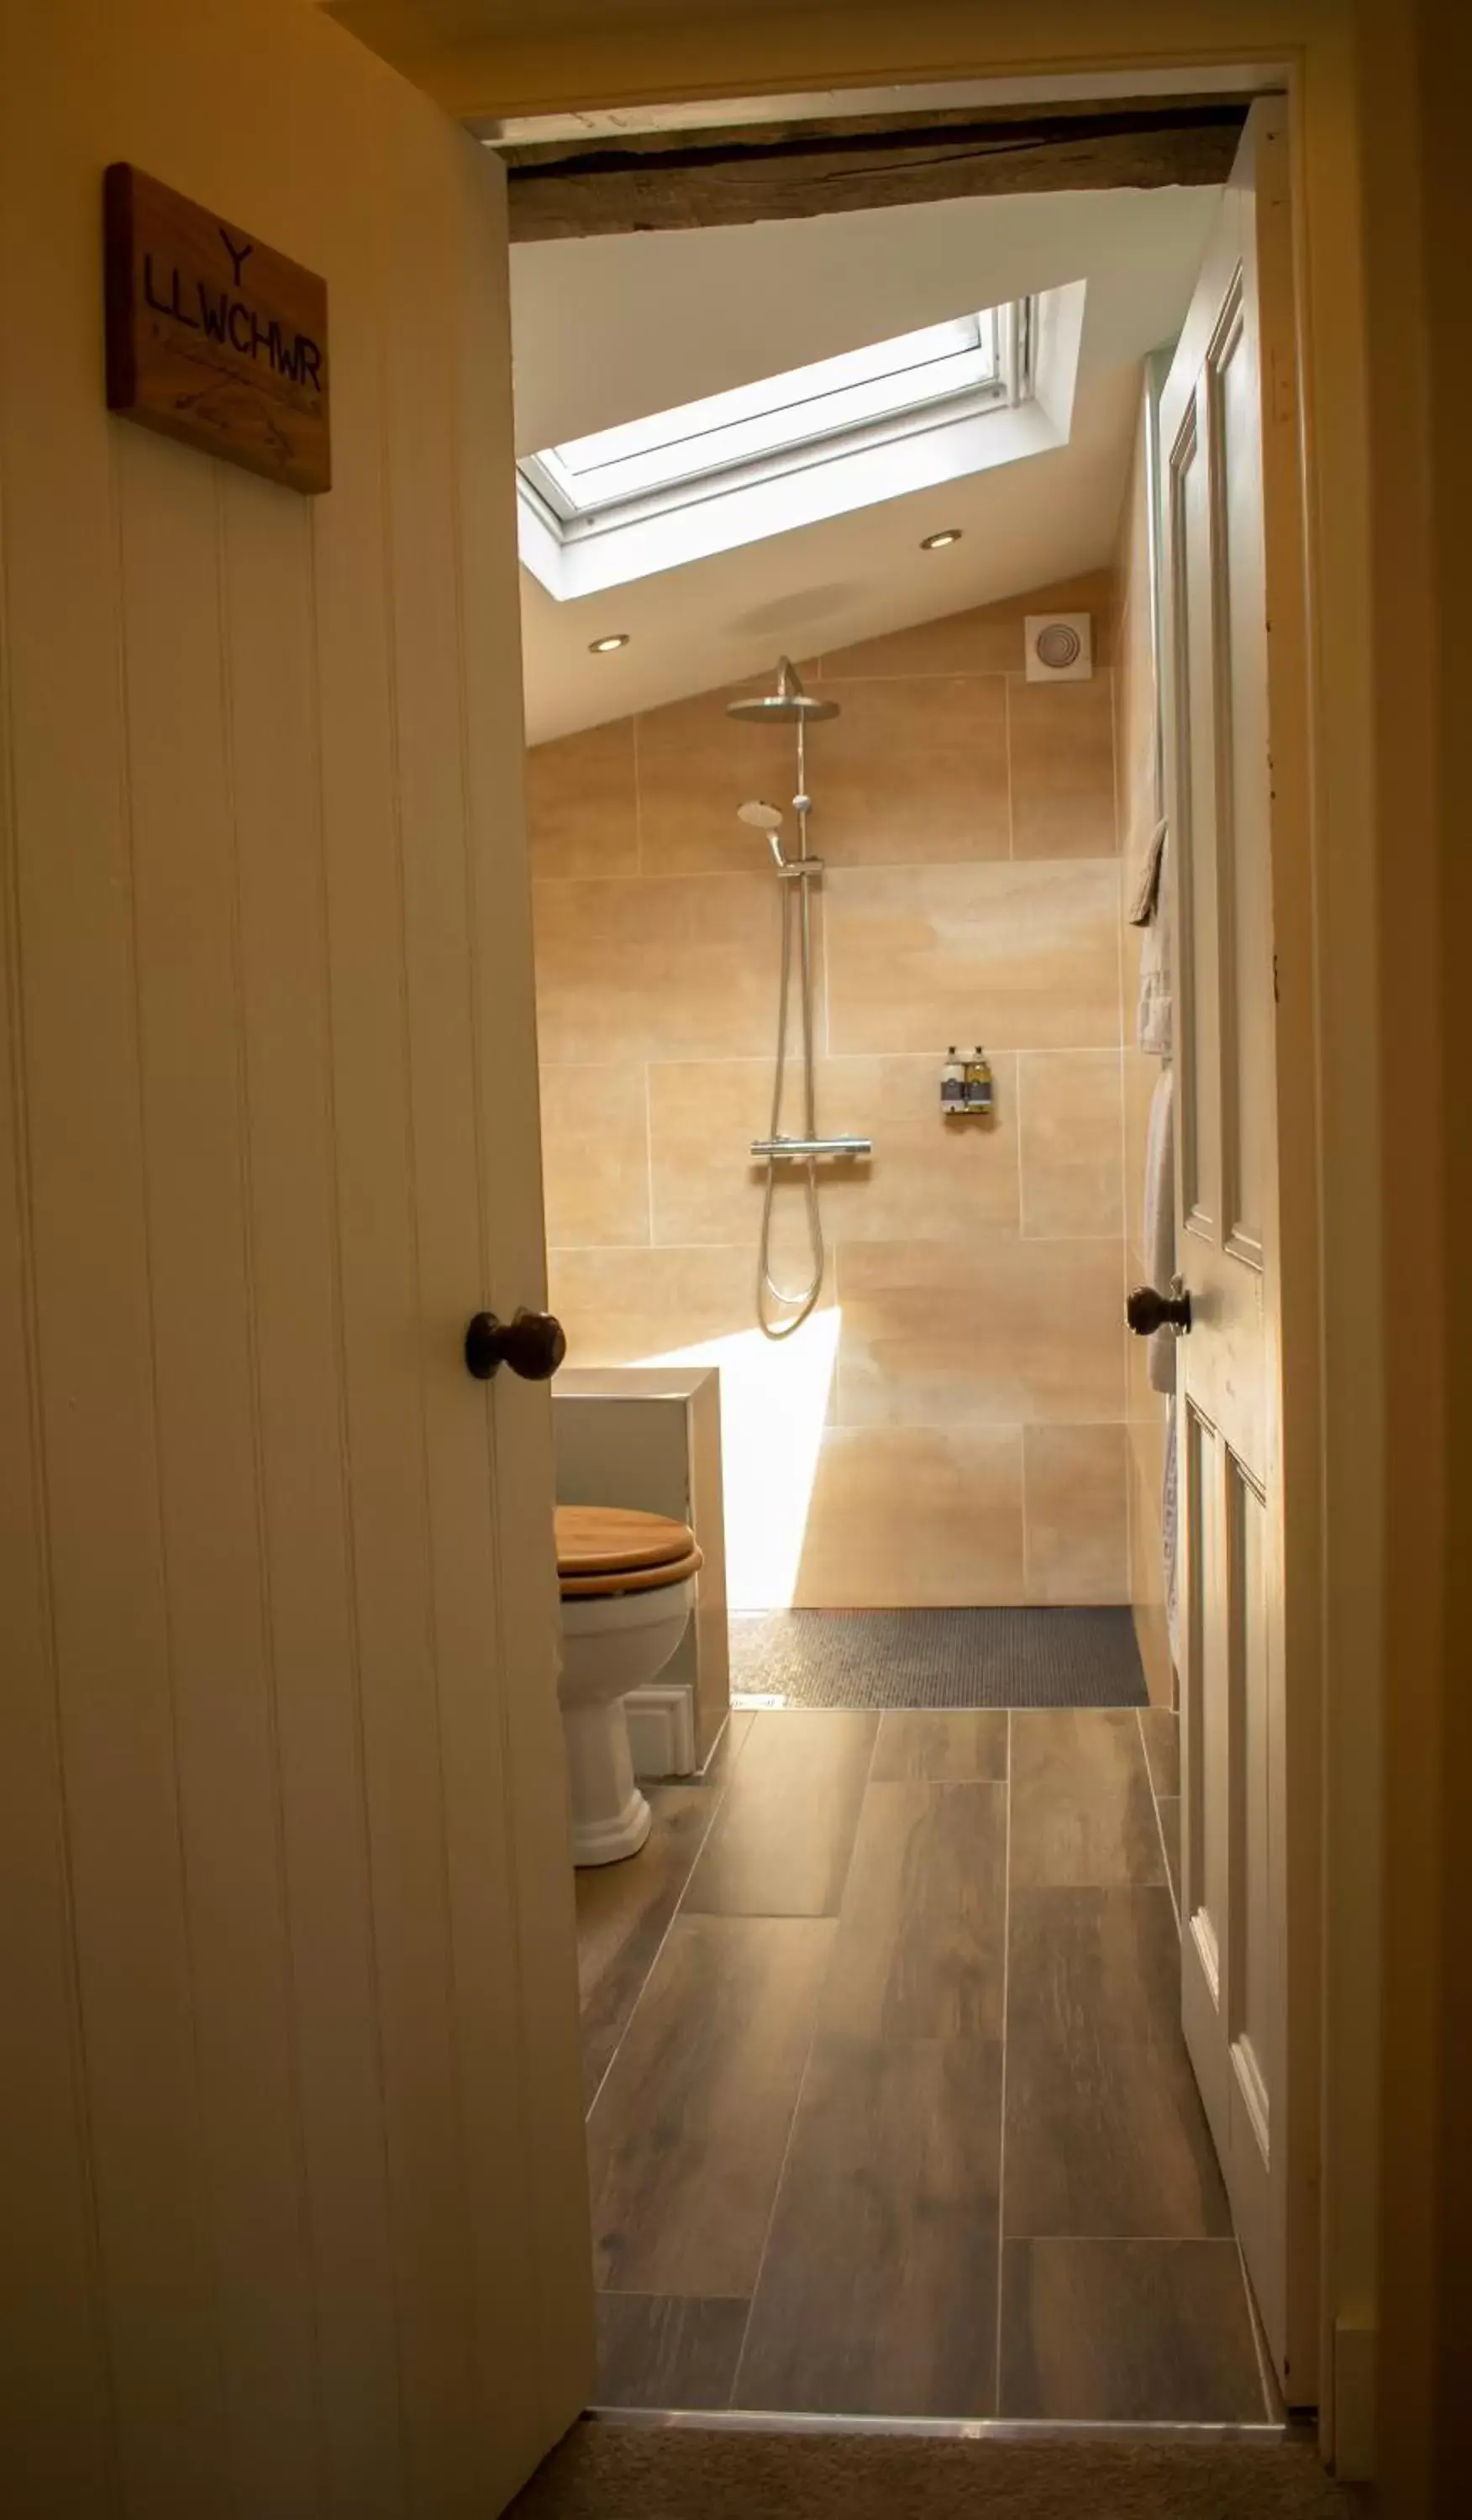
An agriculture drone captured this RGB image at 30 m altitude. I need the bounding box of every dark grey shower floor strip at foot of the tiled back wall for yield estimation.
[731,1608,1147,1706]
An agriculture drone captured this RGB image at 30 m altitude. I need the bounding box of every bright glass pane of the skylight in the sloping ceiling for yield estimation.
[519,302,1031,539]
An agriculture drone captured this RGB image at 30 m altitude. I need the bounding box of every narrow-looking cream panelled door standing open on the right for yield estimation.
[1159,101,1316,2402]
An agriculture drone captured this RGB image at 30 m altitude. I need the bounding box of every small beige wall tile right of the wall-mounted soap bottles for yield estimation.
[1018,1051,1124,1240]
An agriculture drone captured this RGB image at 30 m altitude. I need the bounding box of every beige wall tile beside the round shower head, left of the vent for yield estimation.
[807,673,1011,867]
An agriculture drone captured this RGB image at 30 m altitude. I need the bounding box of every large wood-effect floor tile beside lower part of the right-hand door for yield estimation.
[1003,1895,1233,2240]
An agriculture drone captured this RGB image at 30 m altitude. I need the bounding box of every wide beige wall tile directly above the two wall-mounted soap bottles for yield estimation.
[824,859,1119,1058]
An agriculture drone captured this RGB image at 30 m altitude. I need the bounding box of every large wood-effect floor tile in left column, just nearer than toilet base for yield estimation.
[587,1915,834,2298]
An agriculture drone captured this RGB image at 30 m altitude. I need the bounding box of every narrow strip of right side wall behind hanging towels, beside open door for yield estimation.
[1114,383,1175,1706]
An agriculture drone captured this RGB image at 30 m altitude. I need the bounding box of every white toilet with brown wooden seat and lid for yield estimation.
[557,1504,701,1865]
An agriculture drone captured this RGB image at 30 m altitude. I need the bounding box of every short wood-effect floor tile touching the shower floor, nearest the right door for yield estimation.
[1011,1709,1164,1890]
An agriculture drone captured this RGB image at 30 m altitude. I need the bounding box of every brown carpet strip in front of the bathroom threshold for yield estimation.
[509,2419,1359,2520]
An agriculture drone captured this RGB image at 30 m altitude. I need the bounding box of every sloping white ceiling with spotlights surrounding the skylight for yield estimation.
[512,189,1217,743]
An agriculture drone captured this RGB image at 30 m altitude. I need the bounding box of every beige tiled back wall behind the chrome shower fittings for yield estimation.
[529,575,1132,1608]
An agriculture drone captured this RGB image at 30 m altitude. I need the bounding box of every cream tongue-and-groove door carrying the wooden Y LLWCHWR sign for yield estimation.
[0,0,592,2520]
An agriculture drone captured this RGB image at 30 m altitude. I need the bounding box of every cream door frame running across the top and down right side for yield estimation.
[446,0,1386,2475]
